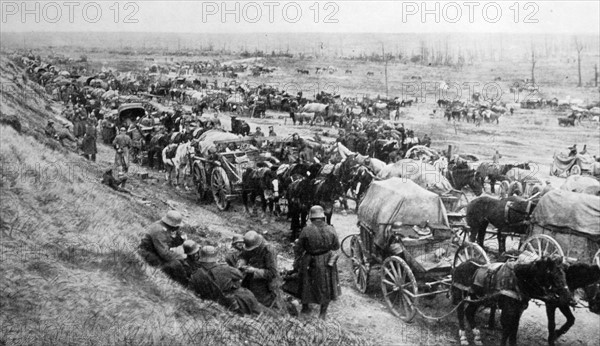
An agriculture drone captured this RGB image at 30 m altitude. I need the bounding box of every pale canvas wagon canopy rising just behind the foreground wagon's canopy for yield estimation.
[377,159,453,194]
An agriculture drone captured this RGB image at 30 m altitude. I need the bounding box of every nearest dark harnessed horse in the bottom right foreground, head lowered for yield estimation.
[452,257,571,346]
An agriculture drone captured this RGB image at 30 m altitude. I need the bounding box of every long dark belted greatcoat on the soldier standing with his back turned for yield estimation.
[298,220,342,304]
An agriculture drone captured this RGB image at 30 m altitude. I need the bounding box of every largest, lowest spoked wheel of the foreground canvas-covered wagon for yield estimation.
[381,256,418,322]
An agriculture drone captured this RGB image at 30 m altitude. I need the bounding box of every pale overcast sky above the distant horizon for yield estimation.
[0,0,600,35]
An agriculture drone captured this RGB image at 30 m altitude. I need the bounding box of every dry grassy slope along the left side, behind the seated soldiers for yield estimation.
[0,58,363,345]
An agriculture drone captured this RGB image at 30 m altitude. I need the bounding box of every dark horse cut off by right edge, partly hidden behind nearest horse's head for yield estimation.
[546,263,600,346]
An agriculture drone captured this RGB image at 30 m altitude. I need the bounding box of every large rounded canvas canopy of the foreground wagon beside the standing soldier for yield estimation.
[358,177,449,231]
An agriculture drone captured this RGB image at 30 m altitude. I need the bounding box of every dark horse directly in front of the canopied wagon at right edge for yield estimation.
[466,196,537,254]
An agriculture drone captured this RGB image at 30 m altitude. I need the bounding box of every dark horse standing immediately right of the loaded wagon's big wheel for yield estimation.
[242,162,279,218]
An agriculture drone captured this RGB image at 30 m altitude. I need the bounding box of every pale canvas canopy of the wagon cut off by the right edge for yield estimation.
[532,189,600,240]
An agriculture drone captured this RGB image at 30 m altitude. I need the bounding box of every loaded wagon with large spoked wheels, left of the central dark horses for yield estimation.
[190,130,259,210]
